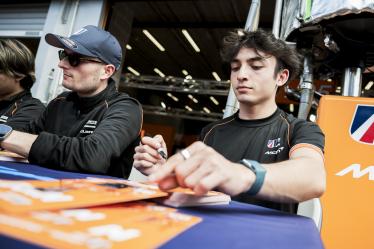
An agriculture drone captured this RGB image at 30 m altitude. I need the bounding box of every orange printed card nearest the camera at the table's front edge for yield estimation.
[0,203,201,249]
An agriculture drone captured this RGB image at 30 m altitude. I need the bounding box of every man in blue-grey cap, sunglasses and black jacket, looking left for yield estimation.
[0,25,142,178]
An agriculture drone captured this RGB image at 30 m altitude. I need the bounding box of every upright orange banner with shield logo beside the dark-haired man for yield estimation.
[318,96,374,249]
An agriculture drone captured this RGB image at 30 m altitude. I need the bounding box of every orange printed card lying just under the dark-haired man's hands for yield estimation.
[0,178,167,213]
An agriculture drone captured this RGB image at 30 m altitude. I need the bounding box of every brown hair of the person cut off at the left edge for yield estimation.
[0,39,35,90]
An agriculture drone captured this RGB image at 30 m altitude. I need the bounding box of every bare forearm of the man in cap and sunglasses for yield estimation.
[1,131,38,158]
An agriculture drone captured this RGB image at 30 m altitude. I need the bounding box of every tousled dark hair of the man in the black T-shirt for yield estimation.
[221,29,303,82]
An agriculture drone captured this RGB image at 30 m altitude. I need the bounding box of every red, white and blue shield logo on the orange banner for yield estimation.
[350,105,374,145]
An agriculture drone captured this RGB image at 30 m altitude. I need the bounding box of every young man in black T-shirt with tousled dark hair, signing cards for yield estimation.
[134,30,326,213]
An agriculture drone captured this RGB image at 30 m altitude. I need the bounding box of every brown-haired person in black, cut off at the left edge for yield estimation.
[0,39,44,130]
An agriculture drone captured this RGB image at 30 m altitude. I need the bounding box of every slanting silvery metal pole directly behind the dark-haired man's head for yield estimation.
[223,0,261,118]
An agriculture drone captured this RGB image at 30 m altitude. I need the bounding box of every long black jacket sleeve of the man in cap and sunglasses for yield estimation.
[28,99,142,174]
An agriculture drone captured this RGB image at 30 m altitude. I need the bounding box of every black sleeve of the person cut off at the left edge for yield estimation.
[7,99,45,131]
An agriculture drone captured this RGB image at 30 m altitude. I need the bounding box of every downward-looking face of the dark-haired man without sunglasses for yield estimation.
[230,47,288,105]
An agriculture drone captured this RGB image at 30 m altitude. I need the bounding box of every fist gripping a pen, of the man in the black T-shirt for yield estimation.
[133,135,167,175]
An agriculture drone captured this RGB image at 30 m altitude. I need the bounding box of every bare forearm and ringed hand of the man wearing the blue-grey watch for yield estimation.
[149,142,326,202]
